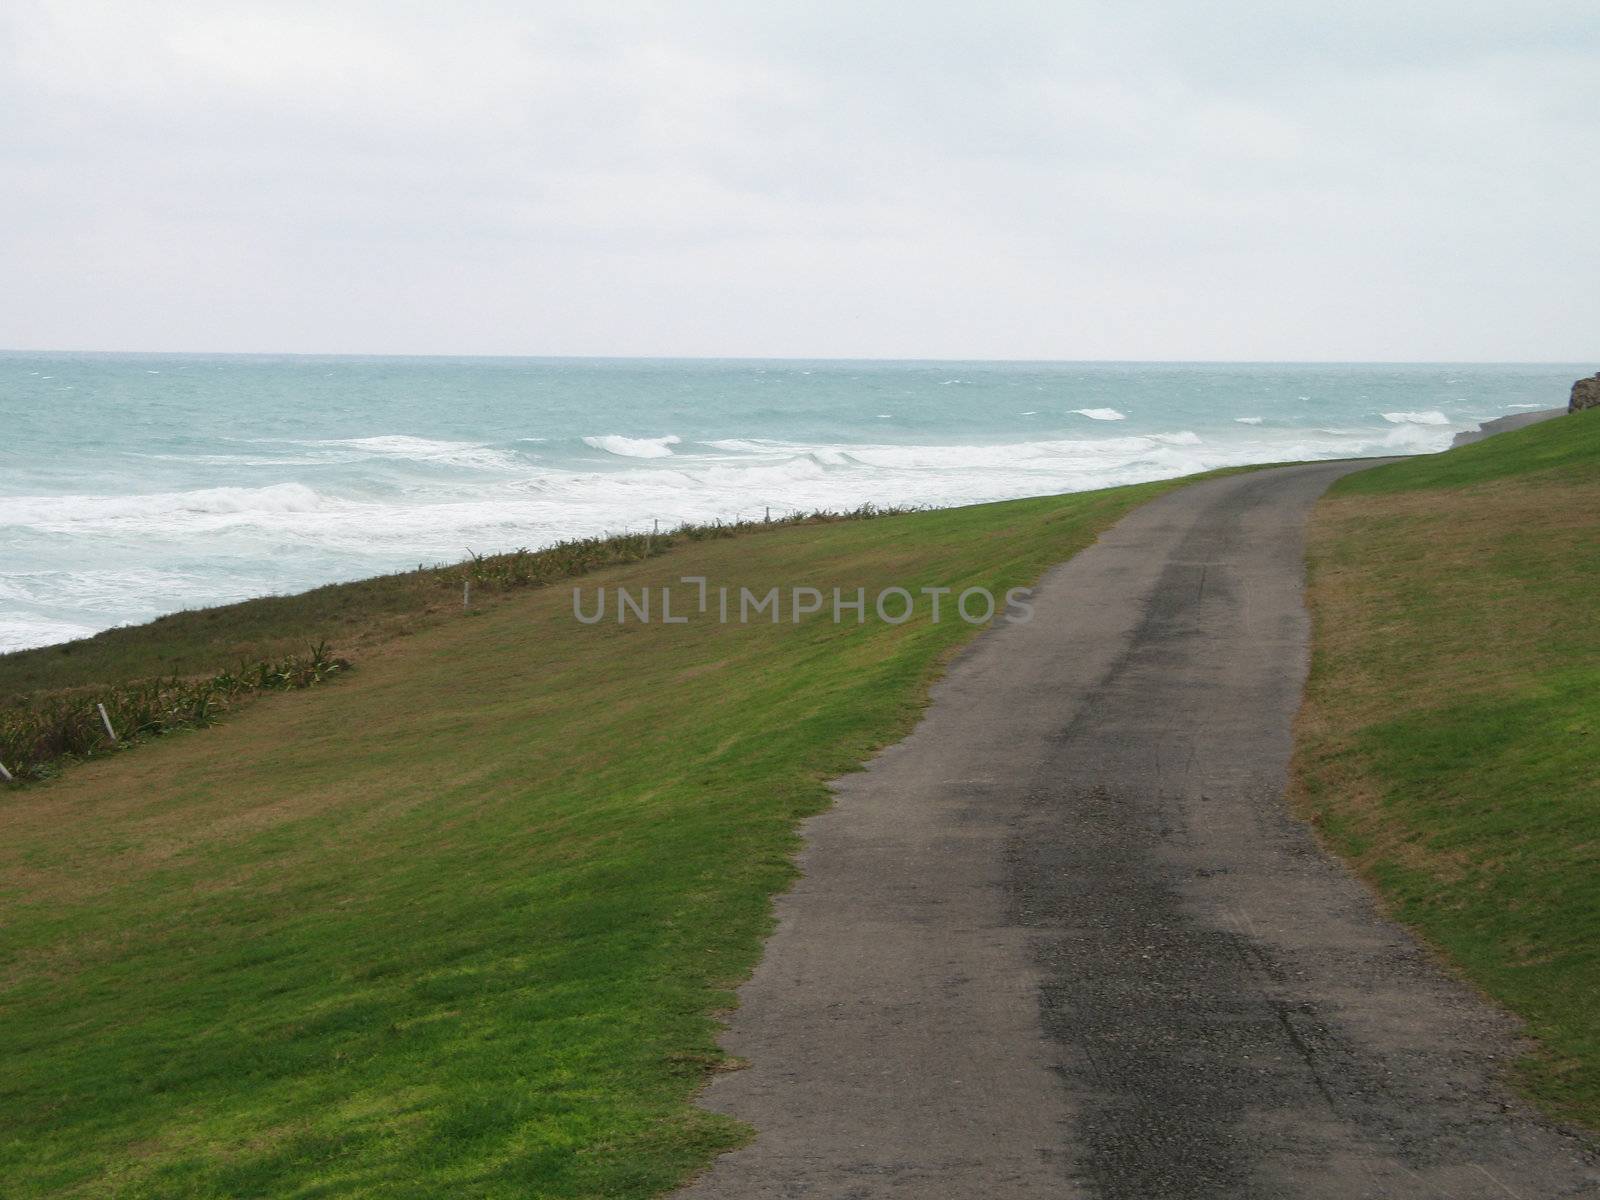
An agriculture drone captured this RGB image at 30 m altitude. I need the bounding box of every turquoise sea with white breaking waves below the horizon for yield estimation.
[0,354,1592,650]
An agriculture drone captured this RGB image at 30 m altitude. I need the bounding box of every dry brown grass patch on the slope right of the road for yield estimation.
[1290,480,1600,883]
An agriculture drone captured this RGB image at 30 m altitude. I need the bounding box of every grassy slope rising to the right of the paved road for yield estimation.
[1296,411,1600,1126]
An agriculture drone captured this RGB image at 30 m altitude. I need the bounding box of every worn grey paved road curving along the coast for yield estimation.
[683,464,1600,1200]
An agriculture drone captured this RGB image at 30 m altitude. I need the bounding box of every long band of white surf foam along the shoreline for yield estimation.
[0,424,1450,659]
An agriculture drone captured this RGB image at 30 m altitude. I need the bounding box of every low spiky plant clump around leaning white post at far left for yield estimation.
[0,642,350,781]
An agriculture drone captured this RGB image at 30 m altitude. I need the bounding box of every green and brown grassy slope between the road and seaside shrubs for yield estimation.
[0,485,1166,1200]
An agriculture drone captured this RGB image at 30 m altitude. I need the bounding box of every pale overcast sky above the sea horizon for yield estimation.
[0,0,1600,365]
